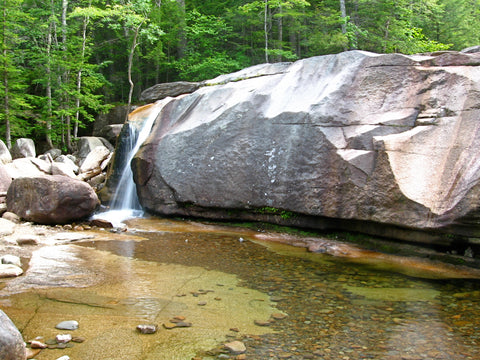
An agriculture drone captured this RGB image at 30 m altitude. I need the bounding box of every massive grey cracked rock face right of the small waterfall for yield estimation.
[129,51,480,236]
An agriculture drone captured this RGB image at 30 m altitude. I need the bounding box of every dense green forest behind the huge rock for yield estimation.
[0,0,480,151]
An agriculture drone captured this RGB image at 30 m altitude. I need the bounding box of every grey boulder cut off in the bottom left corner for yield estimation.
[0,310,26,360]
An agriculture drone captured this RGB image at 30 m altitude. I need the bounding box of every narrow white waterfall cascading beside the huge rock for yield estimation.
[93,98,171,227]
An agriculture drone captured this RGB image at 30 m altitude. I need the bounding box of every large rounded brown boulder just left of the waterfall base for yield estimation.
[7,175,99,224]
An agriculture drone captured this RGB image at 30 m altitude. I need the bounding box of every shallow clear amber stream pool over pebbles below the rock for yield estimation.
[0,218,480,360]
